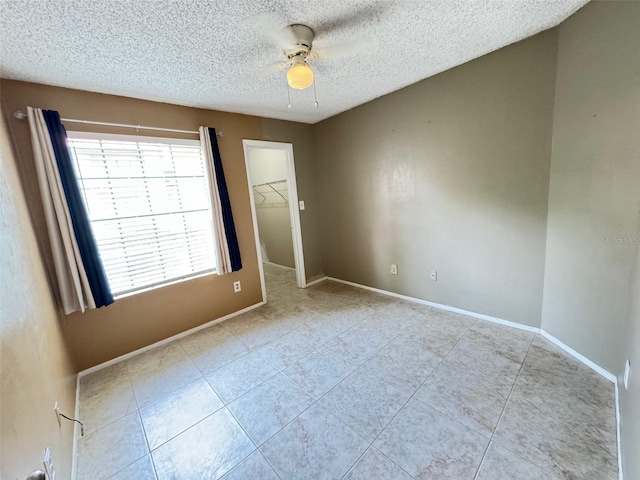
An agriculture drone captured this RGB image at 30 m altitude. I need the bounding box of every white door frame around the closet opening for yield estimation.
[242,140,307,301]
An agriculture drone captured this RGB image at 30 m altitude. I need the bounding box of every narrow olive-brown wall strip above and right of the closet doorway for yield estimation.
[262,118,324,281]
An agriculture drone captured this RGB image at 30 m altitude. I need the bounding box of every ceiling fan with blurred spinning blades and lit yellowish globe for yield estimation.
[254,16,375,90]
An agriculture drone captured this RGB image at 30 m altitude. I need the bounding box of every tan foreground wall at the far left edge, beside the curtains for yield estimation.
[0,109,76,480]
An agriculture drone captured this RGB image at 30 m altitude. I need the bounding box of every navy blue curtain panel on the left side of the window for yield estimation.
[42,110,113,308]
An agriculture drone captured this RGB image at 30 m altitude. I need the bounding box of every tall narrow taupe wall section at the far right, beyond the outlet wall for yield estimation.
[542,2,640,373]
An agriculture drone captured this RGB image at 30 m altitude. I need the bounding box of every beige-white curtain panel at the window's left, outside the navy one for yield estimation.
[28,107,96,313]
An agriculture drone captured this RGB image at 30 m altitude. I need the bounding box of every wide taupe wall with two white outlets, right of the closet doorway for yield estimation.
[316,30,557,326]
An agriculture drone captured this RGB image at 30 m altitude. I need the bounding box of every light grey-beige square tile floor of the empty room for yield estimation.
[77,265,617,480]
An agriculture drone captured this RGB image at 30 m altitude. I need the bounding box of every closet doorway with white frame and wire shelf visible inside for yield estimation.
[242,140,306,301]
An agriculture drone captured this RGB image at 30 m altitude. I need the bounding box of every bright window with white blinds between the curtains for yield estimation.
[68,132,215,296]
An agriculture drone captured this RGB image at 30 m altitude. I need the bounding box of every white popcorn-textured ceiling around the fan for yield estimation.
[0,0,588,123]
